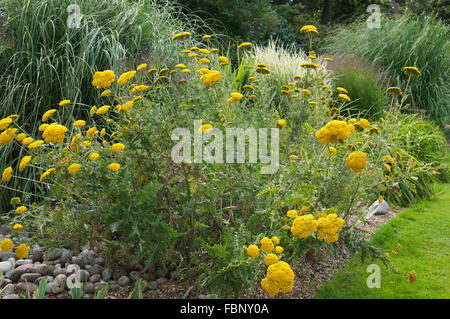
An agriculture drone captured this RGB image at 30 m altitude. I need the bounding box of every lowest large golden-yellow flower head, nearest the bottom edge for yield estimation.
[261,261,295,297]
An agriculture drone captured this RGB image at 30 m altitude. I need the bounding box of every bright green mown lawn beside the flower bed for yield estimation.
[316,184,450,299]
